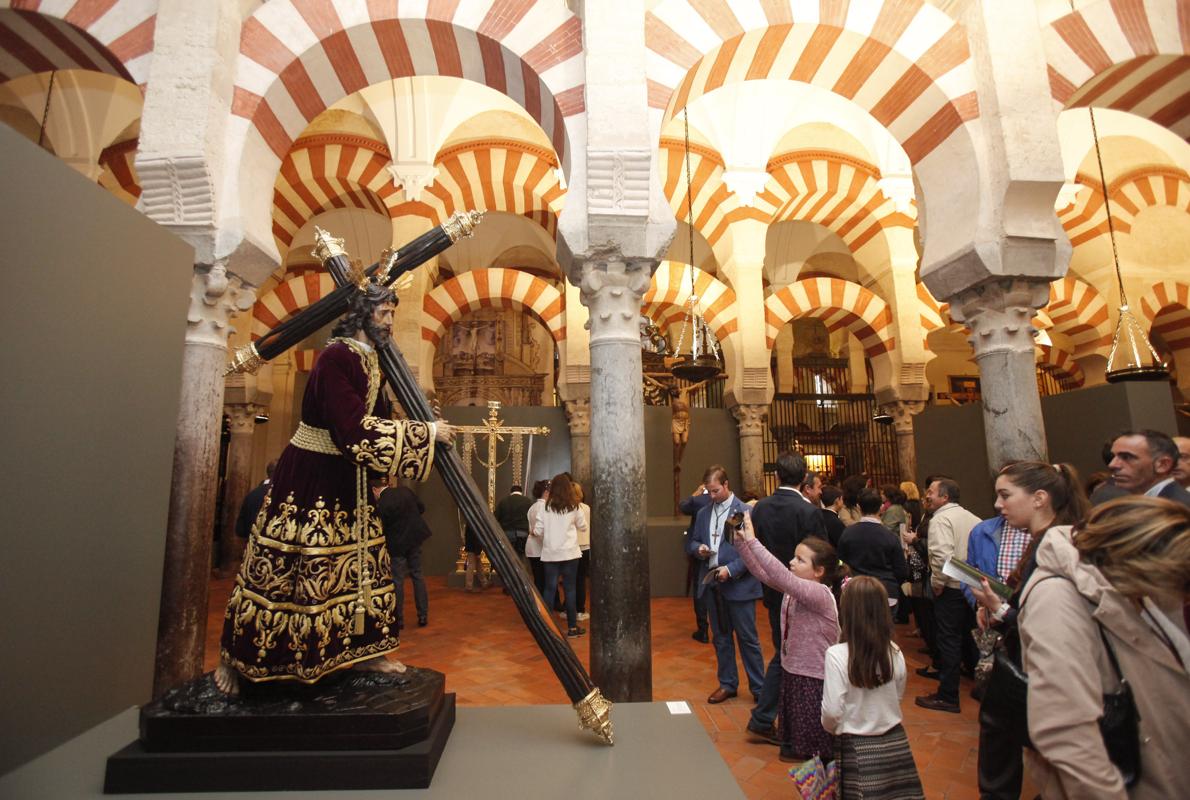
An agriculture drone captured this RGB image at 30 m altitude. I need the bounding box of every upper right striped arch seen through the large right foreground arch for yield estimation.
[757,151,917,255]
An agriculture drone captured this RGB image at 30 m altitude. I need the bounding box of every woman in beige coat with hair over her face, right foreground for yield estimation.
[1020,496,1190,800]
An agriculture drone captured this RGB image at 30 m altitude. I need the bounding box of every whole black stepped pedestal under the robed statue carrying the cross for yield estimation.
[104,668,455,793]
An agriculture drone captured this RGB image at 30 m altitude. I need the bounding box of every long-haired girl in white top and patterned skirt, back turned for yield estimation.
[821,575,925,800]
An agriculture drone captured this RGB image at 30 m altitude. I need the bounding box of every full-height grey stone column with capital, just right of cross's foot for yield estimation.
[580,257,656,702]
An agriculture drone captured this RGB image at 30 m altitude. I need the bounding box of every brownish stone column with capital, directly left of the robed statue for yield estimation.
[154,263,255,696]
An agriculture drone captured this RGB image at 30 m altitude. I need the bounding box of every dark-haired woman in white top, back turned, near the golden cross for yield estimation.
[533,473,587,638]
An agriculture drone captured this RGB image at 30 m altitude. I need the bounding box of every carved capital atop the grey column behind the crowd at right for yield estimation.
[947,277,1050,360]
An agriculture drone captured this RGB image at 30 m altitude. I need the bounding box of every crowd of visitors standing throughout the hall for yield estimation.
[311,431,1190,800]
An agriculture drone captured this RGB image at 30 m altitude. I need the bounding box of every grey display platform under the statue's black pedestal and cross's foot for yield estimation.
[0,702,742,800]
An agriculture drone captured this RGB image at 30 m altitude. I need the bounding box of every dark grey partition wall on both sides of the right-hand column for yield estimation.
[914,382,1177,517]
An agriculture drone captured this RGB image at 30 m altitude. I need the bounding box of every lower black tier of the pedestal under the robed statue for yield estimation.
[104,693,455,794]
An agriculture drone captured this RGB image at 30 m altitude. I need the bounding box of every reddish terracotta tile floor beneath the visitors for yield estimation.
[206,577,1034,800]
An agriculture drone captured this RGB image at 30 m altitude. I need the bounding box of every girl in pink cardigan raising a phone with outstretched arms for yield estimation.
[733,514,837,762]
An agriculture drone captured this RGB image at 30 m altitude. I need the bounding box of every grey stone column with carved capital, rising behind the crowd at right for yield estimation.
[950,279,1050,475]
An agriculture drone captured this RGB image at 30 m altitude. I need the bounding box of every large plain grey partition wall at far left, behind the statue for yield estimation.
[0,126,193,773]
